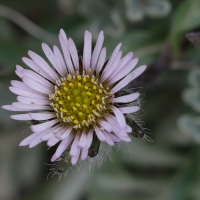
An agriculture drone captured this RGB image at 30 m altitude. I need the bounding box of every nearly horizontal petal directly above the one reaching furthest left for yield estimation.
[12,102,51,111]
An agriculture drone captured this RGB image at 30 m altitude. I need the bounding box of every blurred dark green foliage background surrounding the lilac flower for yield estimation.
[0,0,200,200]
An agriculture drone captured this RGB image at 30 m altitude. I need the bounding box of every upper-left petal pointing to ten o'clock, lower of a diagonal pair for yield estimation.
[22,57,56,83]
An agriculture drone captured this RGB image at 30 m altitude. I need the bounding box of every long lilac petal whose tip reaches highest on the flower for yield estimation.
[59,29,75,74]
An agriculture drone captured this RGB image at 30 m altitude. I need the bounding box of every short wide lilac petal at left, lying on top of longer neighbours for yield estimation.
[22,78,53,94]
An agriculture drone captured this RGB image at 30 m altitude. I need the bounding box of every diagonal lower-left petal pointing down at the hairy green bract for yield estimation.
[51,135,74,162]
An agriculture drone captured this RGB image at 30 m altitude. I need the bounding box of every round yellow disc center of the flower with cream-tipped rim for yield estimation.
[49,74,109,129]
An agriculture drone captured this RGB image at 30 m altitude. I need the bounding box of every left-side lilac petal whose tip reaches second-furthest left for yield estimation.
[9,87,46,99]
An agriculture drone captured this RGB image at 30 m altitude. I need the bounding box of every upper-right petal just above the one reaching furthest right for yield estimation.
[109,58,138,84]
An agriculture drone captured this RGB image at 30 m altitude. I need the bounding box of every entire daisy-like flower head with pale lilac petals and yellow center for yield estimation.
[3,29,146,165]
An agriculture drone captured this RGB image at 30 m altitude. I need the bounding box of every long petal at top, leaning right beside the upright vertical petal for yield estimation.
[91,31,104,70]
